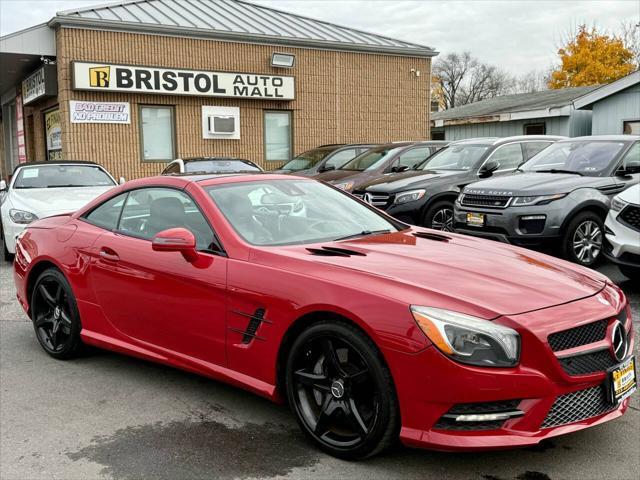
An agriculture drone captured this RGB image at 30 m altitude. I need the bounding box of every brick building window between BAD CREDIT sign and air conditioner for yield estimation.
[139,105,176,162]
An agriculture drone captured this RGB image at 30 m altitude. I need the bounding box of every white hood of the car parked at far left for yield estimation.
[10,185,115,218]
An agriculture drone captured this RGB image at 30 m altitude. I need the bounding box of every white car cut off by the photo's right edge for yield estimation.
[604,184,640,279]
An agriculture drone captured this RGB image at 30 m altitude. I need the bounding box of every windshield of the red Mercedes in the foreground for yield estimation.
[205,179,398,246]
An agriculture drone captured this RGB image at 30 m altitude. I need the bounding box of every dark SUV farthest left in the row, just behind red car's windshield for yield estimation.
[272,143,375,177]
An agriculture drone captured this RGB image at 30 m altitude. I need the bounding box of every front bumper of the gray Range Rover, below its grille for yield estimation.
[454,199,571,246]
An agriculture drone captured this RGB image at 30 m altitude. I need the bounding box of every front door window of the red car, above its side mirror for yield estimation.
[118,188,218,250]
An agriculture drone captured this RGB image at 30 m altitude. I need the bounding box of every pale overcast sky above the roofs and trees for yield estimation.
[0,0,640,74]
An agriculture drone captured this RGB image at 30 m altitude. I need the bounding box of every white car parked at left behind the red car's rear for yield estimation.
[0,162,116,261]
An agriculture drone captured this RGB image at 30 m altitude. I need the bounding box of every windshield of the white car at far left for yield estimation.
[13,165,115,188]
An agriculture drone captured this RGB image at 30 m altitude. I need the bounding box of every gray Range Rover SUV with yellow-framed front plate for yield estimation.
[455,135,640,266]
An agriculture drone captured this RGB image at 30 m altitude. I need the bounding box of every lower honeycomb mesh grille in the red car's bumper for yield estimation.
[540,385,616,428]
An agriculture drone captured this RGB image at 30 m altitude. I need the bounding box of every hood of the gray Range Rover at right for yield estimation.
[464,172,612,196]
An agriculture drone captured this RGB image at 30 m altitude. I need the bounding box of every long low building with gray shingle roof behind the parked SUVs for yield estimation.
[431,86,598,140]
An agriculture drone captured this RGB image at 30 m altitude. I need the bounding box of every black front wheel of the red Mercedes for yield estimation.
[286,322,399,459]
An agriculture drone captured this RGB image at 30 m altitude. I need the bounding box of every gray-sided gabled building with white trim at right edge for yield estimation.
[575,70,640,135]
